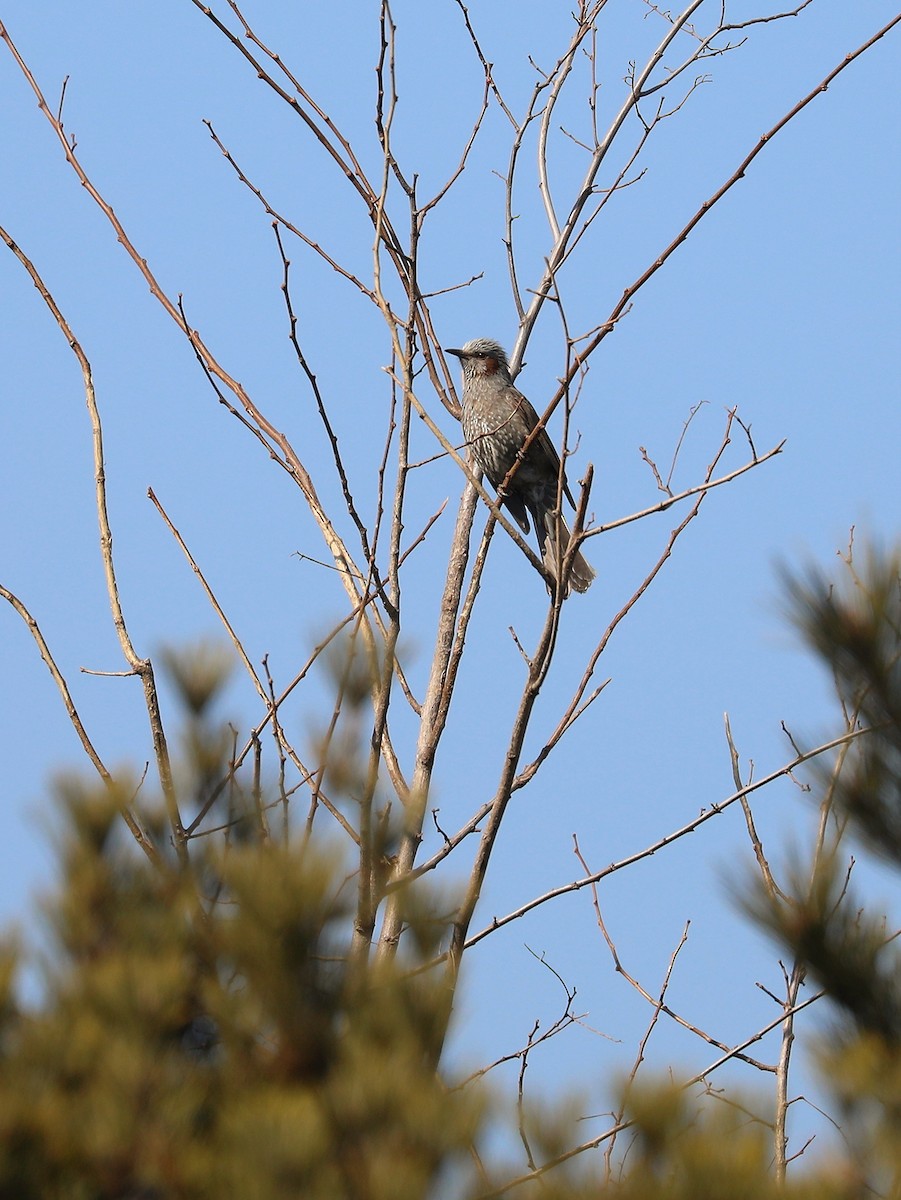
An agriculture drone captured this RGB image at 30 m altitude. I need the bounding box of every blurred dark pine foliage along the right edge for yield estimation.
[752,550,901,1195]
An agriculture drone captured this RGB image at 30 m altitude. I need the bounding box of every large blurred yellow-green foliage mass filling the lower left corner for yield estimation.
[0,791,479,1200]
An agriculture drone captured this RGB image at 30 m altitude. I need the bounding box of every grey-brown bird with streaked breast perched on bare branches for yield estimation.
[446,337,594,595]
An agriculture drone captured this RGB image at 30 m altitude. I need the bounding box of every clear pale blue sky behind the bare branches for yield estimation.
[0,0,901,1176]
